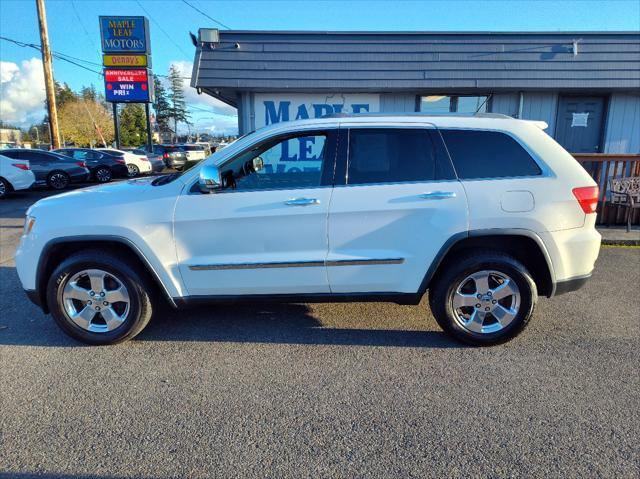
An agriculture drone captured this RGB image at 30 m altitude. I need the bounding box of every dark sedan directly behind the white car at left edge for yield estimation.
[2,148,89,190]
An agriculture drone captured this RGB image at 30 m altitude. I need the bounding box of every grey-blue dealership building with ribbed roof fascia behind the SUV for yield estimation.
[192,29,640,154]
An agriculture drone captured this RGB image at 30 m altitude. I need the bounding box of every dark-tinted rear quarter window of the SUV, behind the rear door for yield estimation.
[440,130,542,180]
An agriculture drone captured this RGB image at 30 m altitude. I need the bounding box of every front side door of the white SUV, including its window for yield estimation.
[174,130,336,296]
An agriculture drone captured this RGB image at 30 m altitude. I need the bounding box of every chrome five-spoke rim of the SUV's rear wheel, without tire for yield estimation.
[452,270,521,334]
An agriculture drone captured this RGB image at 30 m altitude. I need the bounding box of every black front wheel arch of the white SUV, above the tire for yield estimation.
[35,236,177,313]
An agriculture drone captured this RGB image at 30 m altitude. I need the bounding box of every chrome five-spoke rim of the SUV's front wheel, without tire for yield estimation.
[62,269,131,333]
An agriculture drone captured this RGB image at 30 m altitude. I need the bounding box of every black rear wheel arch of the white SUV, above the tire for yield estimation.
[418,229,556,297]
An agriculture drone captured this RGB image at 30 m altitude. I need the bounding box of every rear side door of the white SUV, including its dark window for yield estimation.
[327,125,468,293]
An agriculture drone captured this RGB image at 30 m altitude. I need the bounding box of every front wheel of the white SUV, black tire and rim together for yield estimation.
[47,250,152,344]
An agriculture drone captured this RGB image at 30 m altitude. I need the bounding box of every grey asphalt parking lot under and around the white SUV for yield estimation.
[0,186,640,478]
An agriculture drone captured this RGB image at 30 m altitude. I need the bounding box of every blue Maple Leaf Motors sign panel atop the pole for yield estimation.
[100,16,150,53]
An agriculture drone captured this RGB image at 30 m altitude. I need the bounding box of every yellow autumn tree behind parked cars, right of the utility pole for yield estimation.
[58,100,114,146]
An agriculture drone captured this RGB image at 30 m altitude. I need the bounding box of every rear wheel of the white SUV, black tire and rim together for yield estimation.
[429,251,538,346]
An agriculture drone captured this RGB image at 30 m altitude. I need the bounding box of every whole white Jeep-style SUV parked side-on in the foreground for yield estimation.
[16,115,600,345]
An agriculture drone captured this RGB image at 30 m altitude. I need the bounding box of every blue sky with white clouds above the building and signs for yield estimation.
[0,0,640,134]
